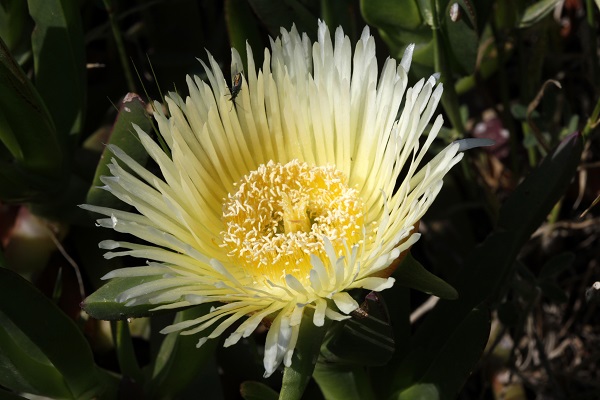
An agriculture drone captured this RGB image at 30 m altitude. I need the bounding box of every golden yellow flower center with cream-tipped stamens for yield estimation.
[221,160,364,283]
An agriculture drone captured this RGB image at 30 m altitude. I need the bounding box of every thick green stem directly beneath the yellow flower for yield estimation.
[279,309,331,400]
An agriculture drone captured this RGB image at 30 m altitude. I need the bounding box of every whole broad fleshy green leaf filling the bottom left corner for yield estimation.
[0,268,116,399]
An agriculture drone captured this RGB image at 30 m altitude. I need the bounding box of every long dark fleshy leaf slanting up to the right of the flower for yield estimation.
[384,134,582,398]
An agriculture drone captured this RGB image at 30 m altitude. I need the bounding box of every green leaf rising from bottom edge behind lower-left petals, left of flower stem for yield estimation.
[147,304,219,398]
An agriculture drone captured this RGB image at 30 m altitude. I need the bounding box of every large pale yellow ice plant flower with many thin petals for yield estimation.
[83,23,462,375]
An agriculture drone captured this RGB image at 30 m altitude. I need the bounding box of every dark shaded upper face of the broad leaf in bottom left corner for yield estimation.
[0,269,106,398]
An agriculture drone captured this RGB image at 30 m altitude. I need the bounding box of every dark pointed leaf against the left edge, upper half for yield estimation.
[0,36,64,202]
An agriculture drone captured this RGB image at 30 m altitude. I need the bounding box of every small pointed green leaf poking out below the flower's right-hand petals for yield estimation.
[393,253,458,300]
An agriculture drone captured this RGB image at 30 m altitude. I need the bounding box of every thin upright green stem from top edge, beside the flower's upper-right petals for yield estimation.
[431,0,465,138]
